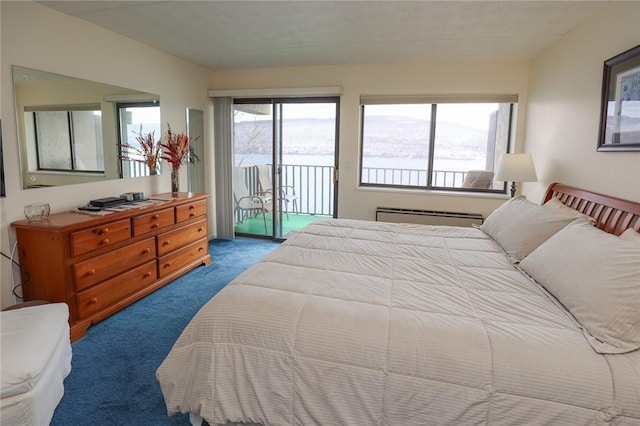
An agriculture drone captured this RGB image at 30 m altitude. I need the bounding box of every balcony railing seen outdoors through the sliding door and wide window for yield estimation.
[235,164,490,220]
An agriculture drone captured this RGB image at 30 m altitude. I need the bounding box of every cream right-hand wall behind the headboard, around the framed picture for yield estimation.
[523,2,640,201]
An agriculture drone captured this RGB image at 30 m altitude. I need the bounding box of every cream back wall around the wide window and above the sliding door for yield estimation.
[210,63,528,220]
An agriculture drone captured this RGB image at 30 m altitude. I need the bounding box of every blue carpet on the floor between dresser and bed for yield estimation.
[51,238,278,426]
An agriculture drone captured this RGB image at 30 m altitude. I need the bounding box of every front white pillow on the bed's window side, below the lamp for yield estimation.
[480,195,582,262]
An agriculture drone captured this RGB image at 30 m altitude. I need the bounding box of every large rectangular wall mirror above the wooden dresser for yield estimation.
[12,65,161,189]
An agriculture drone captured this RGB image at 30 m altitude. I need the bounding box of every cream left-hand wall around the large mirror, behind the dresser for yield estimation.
[0,1,215,307]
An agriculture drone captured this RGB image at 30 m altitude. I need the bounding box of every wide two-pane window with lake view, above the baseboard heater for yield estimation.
[360,96,517,193]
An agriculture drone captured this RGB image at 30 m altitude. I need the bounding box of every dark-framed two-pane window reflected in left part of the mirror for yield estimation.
[25,107,104,173]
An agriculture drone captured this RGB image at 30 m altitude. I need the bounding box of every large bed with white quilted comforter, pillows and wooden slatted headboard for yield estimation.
[157,184,640,425]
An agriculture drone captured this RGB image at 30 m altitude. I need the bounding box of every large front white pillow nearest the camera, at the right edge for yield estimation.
[520,222,640,354]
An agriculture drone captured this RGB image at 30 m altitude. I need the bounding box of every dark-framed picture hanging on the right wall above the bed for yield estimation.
[598,45,640,151]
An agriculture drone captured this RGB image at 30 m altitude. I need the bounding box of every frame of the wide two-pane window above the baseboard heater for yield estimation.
[358,94,518,195]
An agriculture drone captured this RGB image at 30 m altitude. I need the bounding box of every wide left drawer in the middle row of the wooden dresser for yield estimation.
[73,237,156,291]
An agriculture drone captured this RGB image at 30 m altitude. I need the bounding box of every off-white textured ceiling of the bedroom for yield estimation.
[39,0,608,70]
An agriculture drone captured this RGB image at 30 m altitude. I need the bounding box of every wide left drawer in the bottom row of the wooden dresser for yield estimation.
[76,261,156,319]
